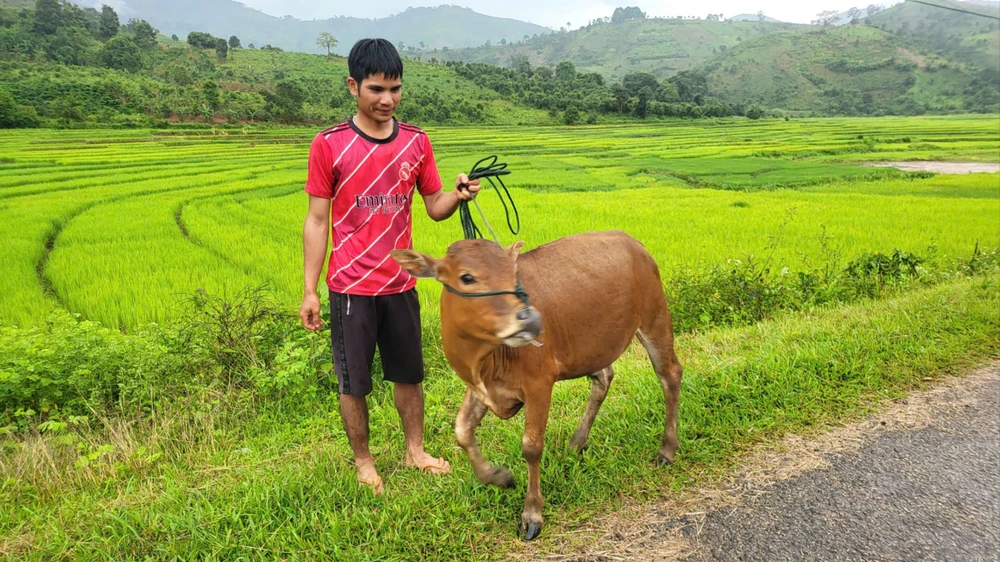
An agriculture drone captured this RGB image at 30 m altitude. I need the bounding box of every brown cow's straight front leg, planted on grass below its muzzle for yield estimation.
[521,386,552,541]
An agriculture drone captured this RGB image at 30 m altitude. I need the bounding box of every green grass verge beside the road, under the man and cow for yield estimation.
[0,278,1000,560]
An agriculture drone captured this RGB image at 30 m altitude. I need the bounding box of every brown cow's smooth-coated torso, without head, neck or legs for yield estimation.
[517,231,666,378]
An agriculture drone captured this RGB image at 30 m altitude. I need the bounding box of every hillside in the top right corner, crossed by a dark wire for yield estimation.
[869,0,1000,71]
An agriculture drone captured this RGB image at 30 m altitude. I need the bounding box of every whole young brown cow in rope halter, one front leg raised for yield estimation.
[392,232,681,540]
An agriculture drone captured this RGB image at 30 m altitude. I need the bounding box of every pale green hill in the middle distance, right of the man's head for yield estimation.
[422,18,804,81]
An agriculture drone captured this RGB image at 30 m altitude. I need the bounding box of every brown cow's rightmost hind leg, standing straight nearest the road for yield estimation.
[639,310,683,465]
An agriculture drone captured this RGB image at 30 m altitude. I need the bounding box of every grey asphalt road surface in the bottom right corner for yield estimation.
[682,369,1000,562]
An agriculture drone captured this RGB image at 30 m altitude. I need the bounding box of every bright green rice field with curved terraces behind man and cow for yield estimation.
[0,116,1000,329]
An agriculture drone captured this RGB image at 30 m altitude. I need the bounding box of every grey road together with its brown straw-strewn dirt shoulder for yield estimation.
[546,366,1000,562]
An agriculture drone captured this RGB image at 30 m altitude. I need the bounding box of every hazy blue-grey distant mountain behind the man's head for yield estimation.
[15,0,552,55]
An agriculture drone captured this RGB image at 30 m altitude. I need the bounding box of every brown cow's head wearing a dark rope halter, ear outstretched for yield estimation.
[392,240,542,347]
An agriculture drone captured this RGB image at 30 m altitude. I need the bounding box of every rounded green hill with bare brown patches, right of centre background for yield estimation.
[698,25,998,115]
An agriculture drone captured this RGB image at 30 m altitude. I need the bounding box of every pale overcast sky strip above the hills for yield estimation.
[234,0,899,29]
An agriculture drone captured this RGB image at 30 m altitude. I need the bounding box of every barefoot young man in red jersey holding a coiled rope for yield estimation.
[299,39,479,495]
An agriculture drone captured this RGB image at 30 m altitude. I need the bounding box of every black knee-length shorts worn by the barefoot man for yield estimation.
[330,289,424,396]
